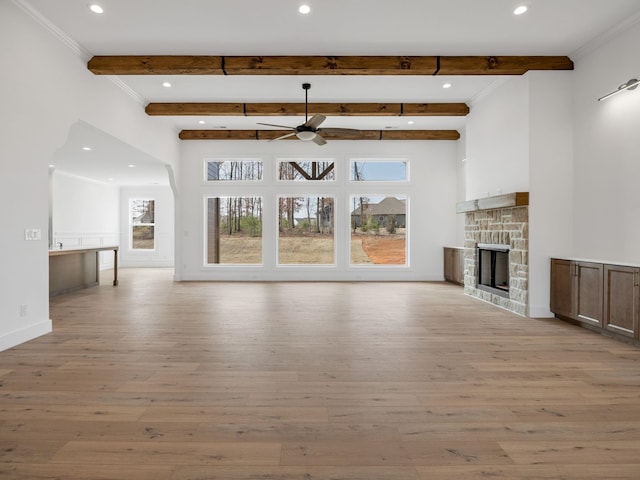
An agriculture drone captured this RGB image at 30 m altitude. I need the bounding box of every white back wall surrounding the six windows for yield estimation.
[176,141,457,280]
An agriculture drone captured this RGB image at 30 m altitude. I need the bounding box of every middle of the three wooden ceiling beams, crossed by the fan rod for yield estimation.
[145,103,469,117]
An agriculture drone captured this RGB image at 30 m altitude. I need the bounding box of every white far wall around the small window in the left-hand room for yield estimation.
[119,186,175,267]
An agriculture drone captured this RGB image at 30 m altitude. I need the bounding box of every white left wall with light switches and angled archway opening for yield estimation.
[0,2,178,350]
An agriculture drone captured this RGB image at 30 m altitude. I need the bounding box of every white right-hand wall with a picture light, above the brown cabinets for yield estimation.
[573,17,640,263]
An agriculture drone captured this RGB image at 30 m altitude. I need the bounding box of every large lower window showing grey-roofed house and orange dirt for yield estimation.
[350,195,407,265]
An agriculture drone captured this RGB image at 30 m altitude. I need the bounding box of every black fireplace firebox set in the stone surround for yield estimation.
[476,243,509,297]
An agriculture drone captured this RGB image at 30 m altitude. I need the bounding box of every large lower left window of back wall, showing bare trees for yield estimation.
[206,197,262,265]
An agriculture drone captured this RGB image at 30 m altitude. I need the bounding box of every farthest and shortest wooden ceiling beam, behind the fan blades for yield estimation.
[179,130,460,140]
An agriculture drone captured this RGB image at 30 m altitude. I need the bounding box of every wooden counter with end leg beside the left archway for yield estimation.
[49,246,118,297]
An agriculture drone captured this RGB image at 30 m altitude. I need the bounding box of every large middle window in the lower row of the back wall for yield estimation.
[278,196,335,265]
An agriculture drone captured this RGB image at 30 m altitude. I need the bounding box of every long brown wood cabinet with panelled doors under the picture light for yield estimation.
[550,258,640,340]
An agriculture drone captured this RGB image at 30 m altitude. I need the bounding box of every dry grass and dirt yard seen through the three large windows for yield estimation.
[214,234,406,265]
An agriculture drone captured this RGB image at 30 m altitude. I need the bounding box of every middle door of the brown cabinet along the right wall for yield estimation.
[575,262,604,327]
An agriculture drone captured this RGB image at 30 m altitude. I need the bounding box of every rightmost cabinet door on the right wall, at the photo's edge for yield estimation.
[604,265,640,338]
